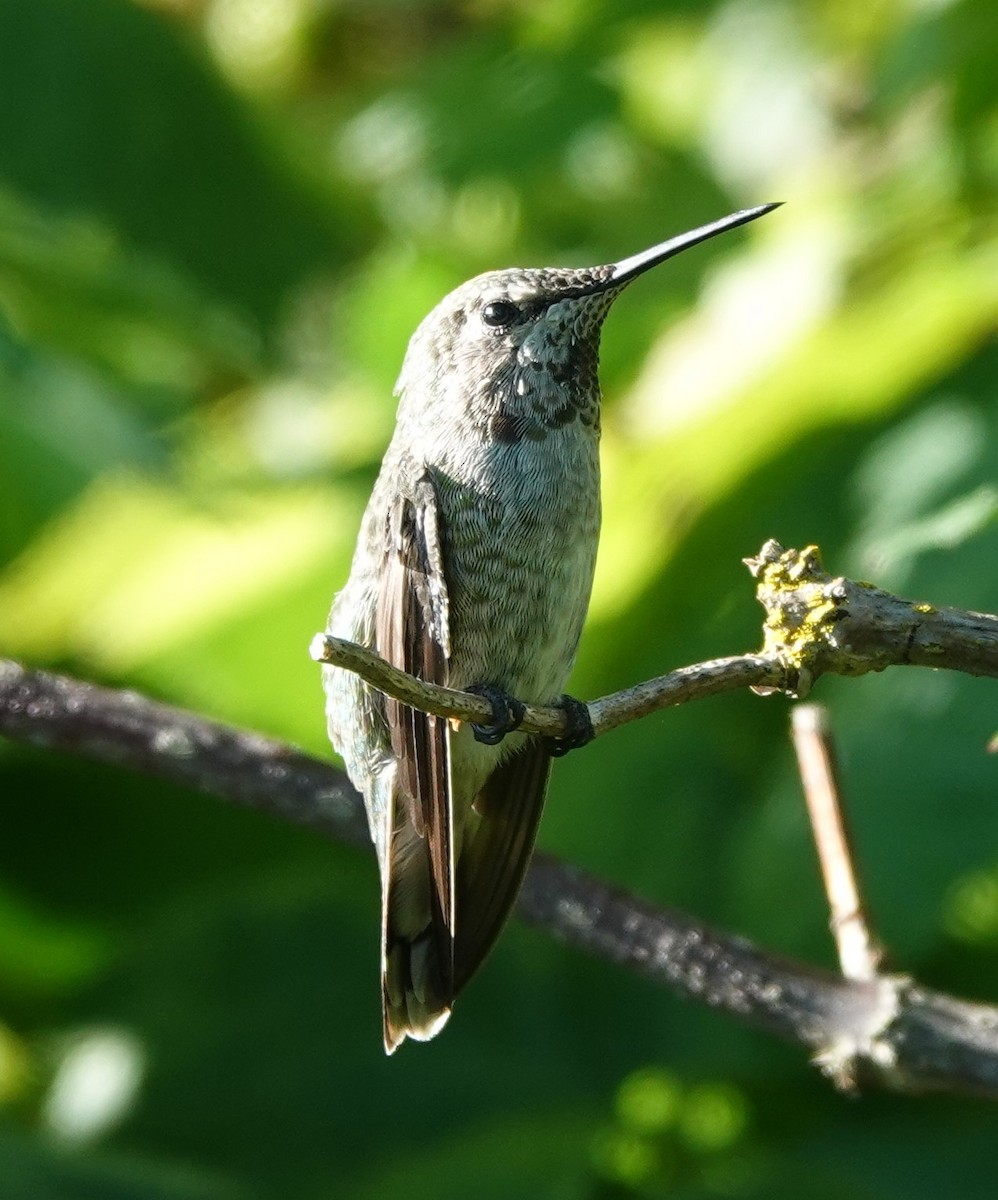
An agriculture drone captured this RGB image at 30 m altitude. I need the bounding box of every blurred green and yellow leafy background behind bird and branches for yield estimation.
[0,0,998,1200]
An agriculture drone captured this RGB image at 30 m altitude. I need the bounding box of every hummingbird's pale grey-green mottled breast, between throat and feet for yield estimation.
[435,422,600,703]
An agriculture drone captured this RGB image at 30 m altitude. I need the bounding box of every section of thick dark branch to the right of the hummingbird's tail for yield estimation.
[519,854,998,1099]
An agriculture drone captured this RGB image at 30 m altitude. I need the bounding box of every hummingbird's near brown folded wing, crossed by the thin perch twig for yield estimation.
[374,472,455,1036]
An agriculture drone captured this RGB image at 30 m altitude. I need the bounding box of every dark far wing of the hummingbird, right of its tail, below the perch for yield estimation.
[453,740,551,992]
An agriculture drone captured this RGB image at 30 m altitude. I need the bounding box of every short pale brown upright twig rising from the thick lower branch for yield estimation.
[792,704,883,979]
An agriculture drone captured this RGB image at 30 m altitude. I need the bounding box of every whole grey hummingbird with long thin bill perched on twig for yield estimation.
[323,204,777,1054]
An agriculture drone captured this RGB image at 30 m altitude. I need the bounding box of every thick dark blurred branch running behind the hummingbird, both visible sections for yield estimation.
[0,660,998,1098]
